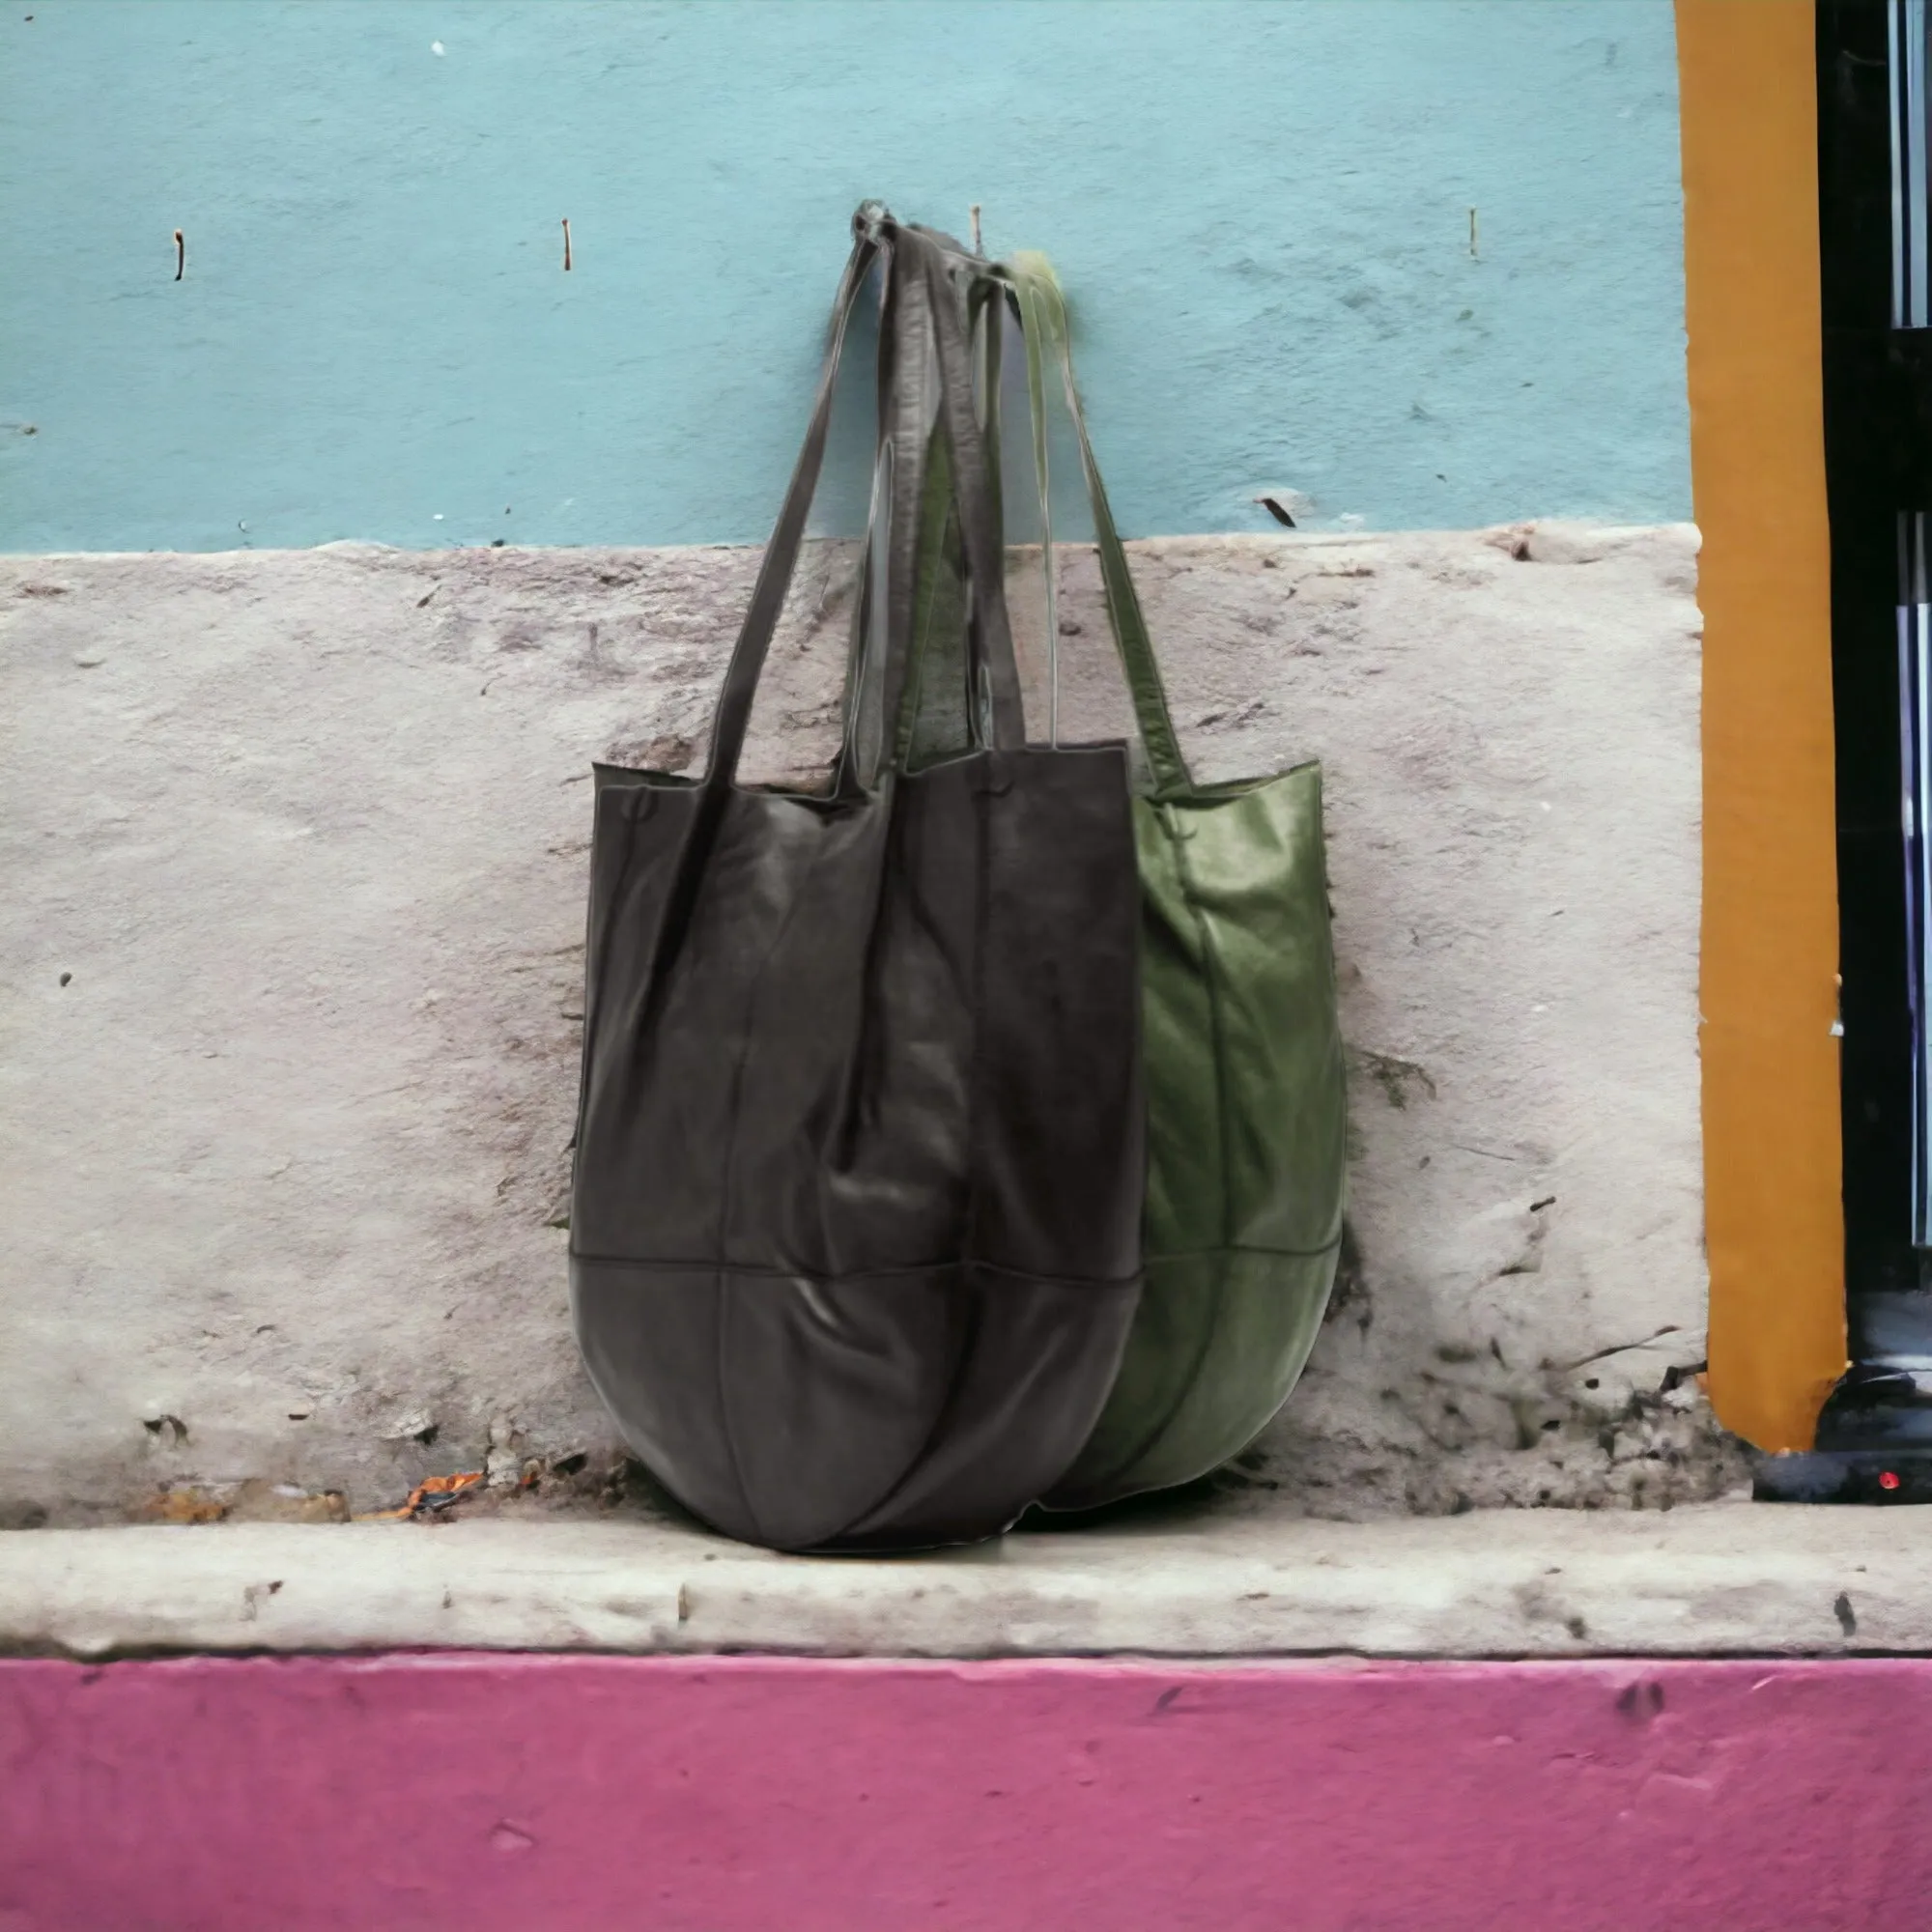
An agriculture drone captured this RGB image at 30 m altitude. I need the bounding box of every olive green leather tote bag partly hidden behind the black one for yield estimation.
[997,255,1345,1509]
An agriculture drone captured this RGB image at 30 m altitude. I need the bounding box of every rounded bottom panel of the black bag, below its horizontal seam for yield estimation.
[570,1258,1140,1549]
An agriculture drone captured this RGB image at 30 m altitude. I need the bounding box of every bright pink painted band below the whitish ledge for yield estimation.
[0,1654,1932,1932]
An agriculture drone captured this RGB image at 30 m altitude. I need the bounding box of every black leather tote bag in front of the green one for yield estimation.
[570,211,1144,1549]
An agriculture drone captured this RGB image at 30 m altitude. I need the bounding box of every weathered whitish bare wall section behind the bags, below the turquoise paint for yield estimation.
[0,526,1737,1520]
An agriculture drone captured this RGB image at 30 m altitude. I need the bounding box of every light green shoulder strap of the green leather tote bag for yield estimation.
[997,253,1194,798]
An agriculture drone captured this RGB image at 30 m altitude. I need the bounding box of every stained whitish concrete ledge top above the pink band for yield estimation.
[0,1503,1932,1658]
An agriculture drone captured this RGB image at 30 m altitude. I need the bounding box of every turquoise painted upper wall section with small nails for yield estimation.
[0,0,1690,551]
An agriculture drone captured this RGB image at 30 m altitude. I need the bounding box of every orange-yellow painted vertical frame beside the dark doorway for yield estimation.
[1677,0,1839,1449]
